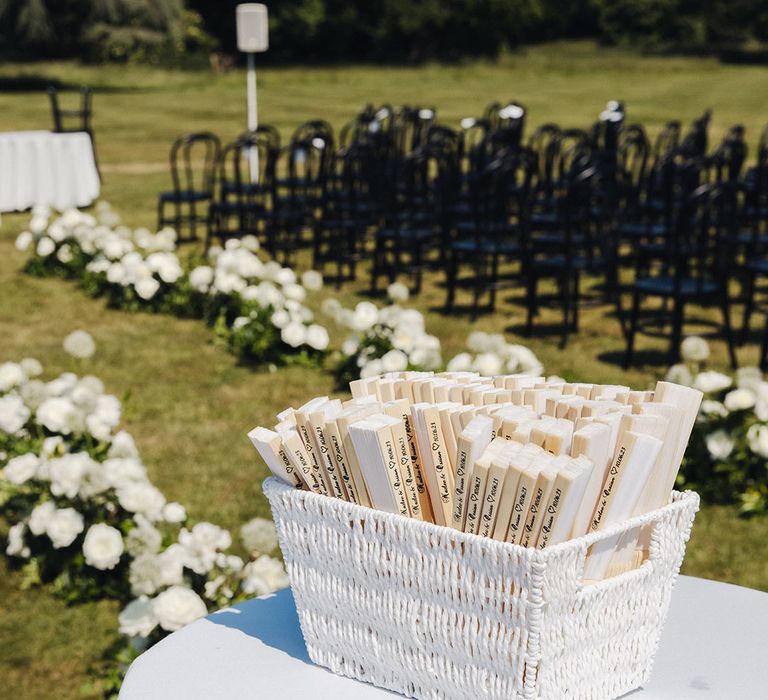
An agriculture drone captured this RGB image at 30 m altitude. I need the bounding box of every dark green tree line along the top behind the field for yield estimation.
[0,0,768,65]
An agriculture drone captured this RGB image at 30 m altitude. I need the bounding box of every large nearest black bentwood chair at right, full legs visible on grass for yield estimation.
[624,184,736,368]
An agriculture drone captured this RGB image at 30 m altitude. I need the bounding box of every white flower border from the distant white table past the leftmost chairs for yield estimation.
[16,202,329,366]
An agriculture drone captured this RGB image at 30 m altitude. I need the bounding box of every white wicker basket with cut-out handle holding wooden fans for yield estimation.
[264,479,699,700]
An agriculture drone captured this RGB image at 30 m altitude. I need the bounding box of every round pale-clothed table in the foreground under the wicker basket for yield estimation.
[120,576,768,700]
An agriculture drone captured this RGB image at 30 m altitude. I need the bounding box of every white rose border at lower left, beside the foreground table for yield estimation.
[0,331,288,694]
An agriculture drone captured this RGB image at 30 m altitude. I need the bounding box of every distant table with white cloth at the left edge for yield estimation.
[0,131,100,212]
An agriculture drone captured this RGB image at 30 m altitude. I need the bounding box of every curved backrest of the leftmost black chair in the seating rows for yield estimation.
[170,131,221,197]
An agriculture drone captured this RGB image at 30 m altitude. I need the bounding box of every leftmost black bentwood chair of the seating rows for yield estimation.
[157,131,221,242]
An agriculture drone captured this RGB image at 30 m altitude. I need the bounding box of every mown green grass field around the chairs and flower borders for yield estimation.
[0,44,768,698]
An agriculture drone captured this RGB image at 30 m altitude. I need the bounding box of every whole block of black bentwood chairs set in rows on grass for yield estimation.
[153,102,768,370]
